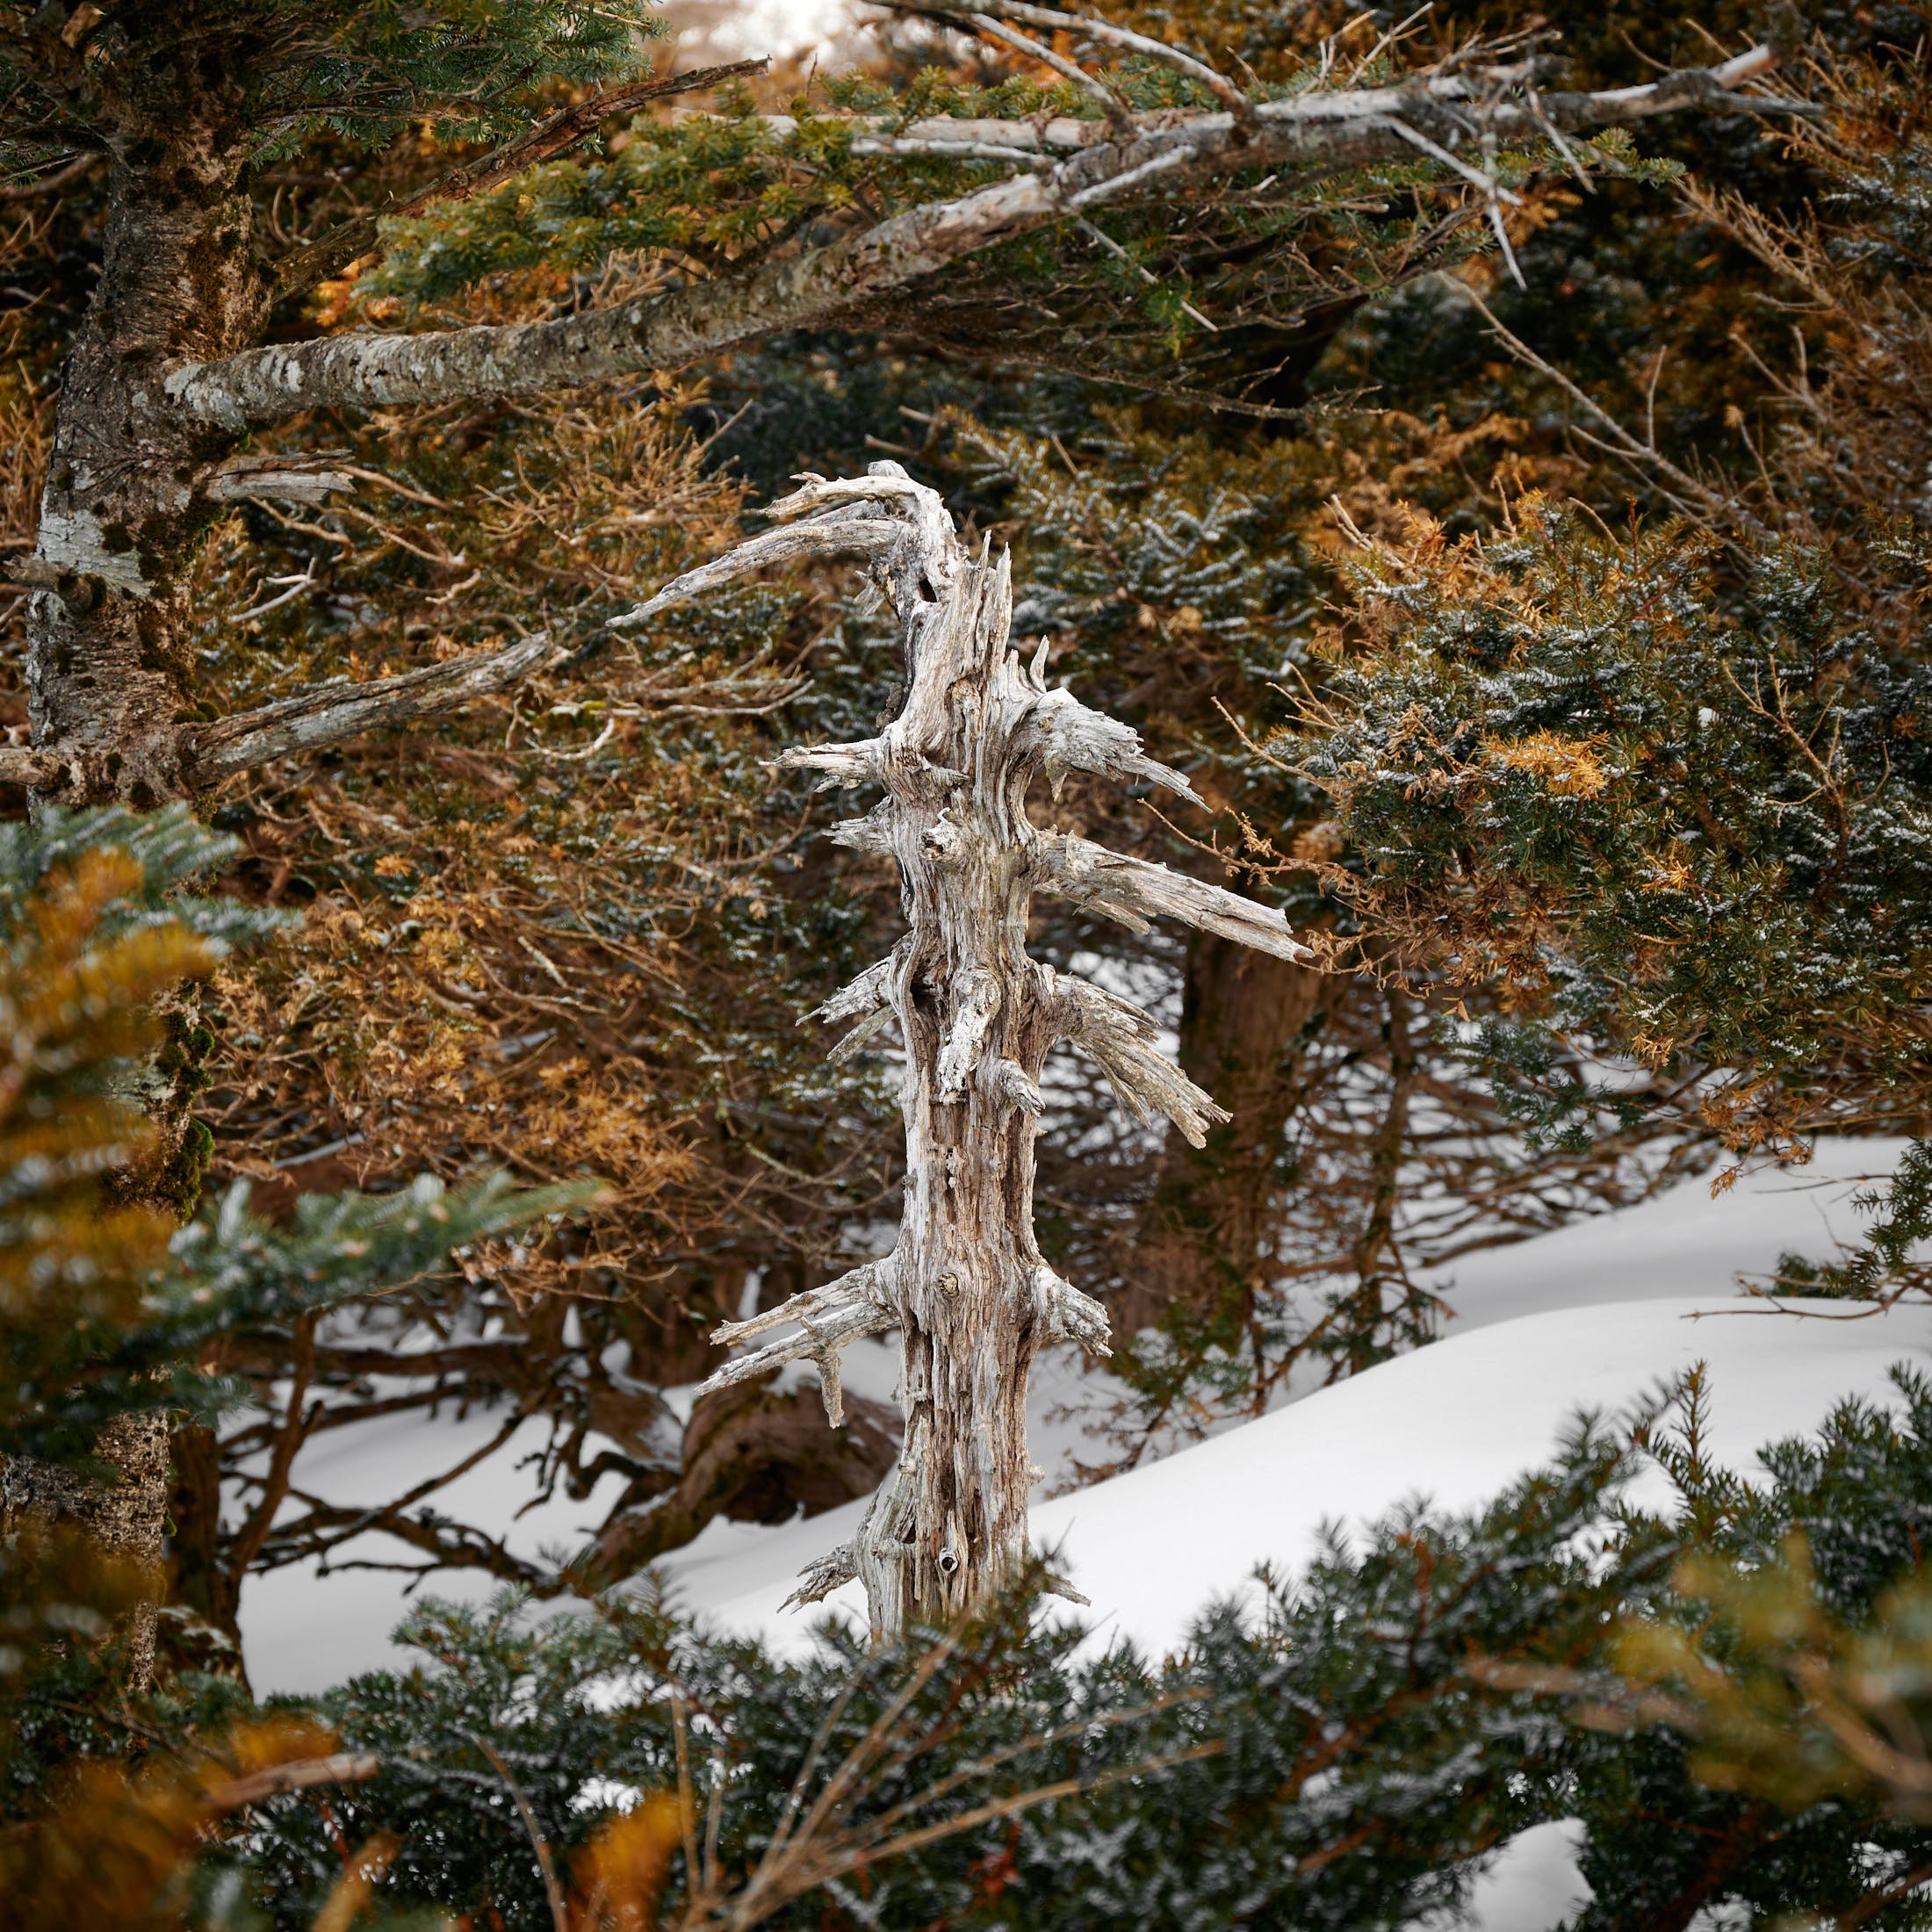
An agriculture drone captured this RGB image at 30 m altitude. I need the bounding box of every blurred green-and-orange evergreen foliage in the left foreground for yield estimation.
[0,805,586,1692]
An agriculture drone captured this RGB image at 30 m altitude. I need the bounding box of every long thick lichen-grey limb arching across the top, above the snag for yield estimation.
[158,47,1789,431]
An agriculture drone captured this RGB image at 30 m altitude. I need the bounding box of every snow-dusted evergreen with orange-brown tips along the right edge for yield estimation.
[1277,18,1932,1294]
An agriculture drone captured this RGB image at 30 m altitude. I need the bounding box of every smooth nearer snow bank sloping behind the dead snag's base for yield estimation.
[665,1296,1932,1654]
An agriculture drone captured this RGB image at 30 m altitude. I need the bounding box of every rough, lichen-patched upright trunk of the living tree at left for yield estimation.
[10,97,261,1684]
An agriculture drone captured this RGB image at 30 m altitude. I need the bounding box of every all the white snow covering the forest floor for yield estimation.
[242,1140,1932,1932]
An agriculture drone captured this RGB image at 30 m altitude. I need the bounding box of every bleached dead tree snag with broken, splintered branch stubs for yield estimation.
[631,464,1304,1633]
